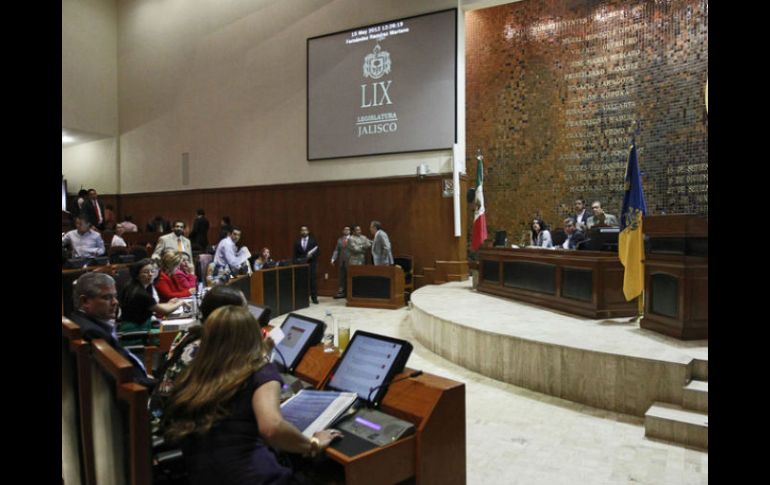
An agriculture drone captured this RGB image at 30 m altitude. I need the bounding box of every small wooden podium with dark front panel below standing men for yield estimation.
[347,265,404,309]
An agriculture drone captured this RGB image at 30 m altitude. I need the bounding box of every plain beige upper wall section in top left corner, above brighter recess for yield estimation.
[62,0,118,136]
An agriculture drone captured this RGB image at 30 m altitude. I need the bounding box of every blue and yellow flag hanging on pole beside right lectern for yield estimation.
[618,143,647,301]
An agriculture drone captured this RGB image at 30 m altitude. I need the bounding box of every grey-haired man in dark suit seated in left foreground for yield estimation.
[69,272,157,390]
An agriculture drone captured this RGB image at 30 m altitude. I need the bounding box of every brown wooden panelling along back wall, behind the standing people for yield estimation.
[112,174,464,295]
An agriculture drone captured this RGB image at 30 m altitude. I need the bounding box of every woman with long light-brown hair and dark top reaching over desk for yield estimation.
[163,305,341,485]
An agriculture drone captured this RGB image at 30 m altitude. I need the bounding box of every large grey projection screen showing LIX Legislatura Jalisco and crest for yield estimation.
[307,10,457,160]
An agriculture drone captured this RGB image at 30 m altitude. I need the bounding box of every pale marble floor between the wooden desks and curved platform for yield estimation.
[280,283,708,485]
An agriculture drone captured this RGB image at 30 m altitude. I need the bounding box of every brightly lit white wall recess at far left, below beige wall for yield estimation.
[61,137,118,194]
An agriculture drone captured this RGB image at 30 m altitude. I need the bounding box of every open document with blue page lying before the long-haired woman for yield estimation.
[281,389,358,438]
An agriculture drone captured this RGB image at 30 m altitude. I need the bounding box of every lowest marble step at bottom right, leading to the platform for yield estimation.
[644,402,708,450]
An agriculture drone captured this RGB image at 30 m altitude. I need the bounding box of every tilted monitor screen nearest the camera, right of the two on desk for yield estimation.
[326,330,412,404]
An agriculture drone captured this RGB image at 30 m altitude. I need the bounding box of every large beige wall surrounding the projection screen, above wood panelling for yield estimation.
[118,0,465,193]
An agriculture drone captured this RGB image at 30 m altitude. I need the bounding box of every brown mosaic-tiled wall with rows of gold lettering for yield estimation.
[466,0,708,246]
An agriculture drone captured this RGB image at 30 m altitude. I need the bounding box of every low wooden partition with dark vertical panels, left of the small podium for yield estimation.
[249,264,310,317]
